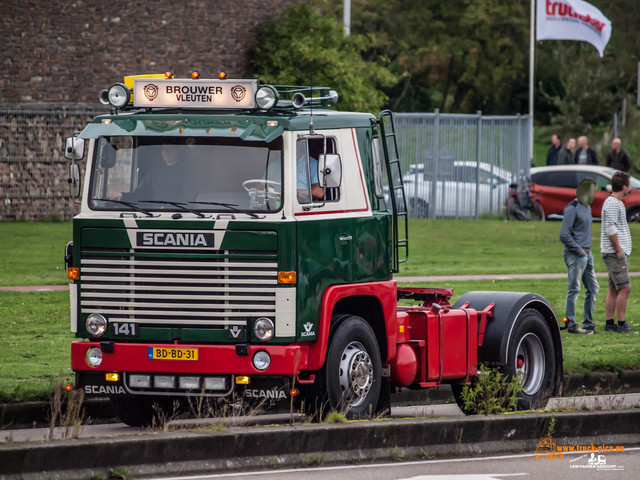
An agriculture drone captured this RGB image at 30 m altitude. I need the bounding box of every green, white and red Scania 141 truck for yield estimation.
[65,72,562,425]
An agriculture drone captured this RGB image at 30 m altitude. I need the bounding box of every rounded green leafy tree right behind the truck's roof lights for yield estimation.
[253,4,399,112]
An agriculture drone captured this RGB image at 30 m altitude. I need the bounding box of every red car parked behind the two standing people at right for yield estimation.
[531,165,640,222]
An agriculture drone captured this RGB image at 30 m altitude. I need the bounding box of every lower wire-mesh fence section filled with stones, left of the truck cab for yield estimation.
[0,103,105,220]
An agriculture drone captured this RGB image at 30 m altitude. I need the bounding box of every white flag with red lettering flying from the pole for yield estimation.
[536,0,611,57]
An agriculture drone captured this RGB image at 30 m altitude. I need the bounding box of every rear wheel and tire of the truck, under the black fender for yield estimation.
[504,309,556,410]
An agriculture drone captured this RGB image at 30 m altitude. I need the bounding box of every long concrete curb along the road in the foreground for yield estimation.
[0,409,640,480]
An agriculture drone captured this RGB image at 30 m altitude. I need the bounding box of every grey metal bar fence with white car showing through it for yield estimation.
[393,111,531,218]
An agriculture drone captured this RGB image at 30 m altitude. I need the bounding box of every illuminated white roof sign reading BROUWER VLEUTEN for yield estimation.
[133,78,258,109]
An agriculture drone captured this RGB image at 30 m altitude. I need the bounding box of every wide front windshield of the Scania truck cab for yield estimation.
[90,137,282,213]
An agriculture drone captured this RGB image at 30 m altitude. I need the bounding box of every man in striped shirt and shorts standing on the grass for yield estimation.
[600,172,638,333]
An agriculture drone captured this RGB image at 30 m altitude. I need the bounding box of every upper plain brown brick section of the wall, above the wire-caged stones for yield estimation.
[0,0,295,103]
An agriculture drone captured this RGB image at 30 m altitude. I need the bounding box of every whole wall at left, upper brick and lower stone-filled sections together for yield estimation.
[0,0,299,221]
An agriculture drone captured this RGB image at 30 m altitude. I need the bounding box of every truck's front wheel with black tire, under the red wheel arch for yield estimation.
[322,316,384,419]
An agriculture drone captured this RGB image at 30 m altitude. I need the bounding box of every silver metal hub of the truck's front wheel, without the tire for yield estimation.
[339,342,373,407]
